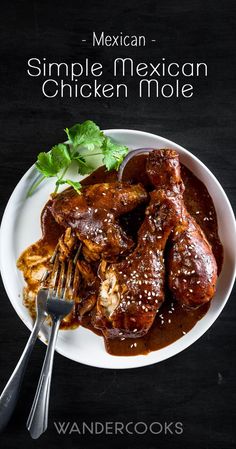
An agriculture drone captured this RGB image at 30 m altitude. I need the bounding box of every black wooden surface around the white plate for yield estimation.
[0,0,236,449]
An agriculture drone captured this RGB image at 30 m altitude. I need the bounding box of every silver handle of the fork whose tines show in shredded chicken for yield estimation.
[26,319,61,439]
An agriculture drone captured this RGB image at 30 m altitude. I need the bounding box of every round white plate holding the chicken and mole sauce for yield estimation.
[0,129,236,368]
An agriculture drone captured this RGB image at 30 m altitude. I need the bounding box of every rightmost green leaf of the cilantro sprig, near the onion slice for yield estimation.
[102,137,129,170]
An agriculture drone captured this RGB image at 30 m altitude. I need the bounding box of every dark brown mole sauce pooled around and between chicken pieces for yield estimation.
[41,155,223,356]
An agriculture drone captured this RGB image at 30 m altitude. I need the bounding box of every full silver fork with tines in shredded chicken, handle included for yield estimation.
[26,255,75,439]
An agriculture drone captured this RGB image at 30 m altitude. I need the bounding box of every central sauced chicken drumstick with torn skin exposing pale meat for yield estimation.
[94,187,181,338]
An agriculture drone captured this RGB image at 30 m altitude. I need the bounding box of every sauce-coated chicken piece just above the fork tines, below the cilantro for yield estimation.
[51,182,148,262]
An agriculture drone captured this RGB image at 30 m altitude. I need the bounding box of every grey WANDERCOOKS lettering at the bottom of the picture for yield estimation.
[54,421,184,435]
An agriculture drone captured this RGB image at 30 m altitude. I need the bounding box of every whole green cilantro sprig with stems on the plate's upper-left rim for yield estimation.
[28,120,128,196]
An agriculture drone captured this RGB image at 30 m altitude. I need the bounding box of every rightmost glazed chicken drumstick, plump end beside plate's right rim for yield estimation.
[146,150,217,308]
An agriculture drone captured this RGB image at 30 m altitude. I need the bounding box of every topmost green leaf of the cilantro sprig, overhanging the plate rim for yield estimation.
[65,120,104,151]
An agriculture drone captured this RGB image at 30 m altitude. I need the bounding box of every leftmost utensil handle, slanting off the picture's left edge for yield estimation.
[0,316,45,432]
